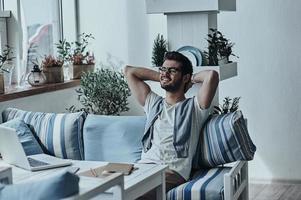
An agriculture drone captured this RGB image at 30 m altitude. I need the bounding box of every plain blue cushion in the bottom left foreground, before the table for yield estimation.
[0,172,79,200]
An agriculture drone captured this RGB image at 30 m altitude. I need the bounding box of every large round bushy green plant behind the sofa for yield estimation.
[67,64,130,115]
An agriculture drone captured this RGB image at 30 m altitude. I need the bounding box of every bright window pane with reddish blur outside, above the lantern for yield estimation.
[22,0,61,75]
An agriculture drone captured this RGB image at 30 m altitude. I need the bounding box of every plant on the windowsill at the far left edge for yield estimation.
[0,45,13,94]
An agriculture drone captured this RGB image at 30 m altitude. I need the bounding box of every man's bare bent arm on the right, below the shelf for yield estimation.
[191,70,219,109]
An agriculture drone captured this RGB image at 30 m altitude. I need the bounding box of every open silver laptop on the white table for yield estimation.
[0,125,72,171]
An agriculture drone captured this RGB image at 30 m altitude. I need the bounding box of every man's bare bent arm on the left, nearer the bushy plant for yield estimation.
[124,65,160,106]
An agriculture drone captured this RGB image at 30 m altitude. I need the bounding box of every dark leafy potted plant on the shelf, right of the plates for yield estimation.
[205,28,237,66]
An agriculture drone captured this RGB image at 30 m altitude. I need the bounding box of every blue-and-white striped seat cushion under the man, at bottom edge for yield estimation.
[167,167,231,200]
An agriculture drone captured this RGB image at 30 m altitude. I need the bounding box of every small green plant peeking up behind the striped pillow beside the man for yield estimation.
[213,97,241,114]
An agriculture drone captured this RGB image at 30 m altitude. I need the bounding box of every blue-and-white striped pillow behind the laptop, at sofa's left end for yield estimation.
[2,108,86,160]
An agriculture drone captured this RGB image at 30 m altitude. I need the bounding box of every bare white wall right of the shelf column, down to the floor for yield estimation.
[218,0,301,180]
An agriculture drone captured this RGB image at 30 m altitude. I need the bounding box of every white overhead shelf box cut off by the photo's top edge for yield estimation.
[145,0,236,14]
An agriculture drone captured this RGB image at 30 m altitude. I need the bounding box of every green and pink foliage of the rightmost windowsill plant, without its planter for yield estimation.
[56,33,95,65]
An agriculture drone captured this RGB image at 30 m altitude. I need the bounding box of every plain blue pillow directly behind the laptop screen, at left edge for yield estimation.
[1,119,43,156]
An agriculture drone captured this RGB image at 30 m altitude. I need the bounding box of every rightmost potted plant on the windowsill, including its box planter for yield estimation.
[56,33,95,79]
